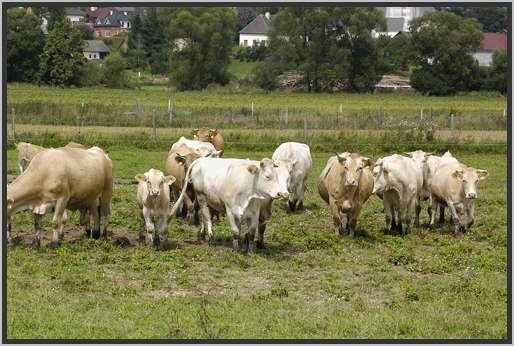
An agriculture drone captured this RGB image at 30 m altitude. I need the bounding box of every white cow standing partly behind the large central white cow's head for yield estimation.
[271,142,312,212]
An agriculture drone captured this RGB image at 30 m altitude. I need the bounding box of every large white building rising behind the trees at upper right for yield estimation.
[373,7,435,37]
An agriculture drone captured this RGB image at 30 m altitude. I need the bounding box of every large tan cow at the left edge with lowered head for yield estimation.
[6,147,113,246]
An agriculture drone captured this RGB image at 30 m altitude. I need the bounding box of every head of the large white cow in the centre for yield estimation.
[247,158,289,199]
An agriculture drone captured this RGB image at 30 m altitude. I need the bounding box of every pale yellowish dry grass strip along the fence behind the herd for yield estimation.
[7,123,507,143]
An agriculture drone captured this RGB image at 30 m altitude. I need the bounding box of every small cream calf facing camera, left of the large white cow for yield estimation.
[135,168,175,247]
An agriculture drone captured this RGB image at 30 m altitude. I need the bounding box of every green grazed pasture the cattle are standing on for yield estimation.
[7,137,507,339]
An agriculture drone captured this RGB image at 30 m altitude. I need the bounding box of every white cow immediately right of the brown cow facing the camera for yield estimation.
[373,154,423,235]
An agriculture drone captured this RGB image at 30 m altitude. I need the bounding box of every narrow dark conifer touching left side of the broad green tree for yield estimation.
[141,8,168,74]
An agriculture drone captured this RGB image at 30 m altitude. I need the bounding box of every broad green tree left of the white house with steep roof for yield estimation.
[161,7,235,90]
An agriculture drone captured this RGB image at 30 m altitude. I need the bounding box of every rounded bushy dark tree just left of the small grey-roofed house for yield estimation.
[39,20,86,86]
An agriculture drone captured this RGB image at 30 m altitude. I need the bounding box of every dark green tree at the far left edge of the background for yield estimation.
[6,8,44,82]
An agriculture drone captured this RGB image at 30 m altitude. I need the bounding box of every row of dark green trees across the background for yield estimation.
[7,7,508,95]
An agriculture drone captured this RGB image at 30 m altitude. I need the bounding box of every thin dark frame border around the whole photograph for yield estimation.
[2,1,512,344]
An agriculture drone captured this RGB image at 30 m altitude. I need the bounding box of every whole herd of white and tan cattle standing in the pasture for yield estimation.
[6,128,488,251]
